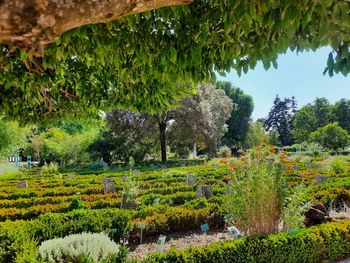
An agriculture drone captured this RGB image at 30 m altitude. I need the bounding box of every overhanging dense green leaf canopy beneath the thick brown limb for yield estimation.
[0,0,350,121]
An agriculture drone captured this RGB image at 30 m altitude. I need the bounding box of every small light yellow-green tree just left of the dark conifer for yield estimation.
[243,121,269,149]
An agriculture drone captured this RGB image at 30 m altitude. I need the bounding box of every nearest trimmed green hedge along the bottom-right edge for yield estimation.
[142,220,350,263]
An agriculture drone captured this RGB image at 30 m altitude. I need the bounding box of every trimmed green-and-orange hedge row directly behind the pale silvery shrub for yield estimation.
[0,204,224,263]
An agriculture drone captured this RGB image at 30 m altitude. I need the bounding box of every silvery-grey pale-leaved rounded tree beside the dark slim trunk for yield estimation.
[169,84,233,158]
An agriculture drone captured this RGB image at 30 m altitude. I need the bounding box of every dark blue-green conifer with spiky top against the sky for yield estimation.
[264,95,296,146]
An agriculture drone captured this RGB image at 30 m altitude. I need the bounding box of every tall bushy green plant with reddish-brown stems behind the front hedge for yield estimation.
[225,160,309,235]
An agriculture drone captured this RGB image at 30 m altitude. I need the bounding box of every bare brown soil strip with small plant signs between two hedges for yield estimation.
[128,230,233,258]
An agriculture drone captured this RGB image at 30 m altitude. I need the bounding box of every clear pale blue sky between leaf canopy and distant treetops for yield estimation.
[218,48,350,119]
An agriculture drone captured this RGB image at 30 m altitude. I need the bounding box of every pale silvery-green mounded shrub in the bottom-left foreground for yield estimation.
[39,233,119,263]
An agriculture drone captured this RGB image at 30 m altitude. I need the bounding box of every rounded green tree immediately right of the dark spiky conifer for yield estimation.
[293,98,335,143]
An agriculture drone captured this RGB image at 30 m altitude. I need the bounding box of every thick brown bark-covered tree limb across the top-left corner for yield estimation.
[0,0,192,52]
